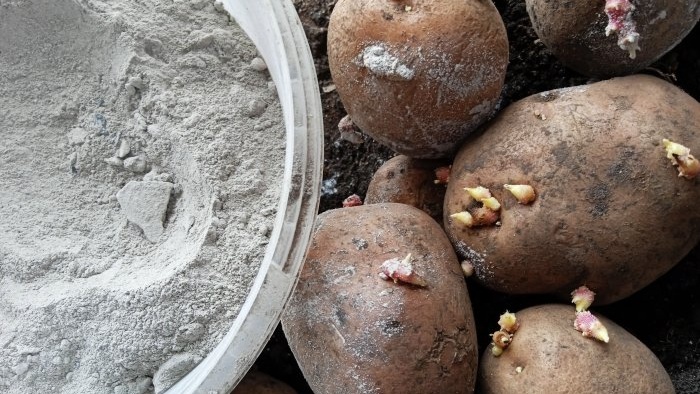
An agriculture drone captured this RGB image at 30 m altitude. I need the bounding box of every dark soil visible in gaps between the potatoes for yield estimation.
[256,0,700,394]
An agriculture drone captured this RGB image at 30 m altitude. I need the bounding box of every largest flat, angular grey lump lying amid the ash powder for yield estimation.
[117,181,173,242]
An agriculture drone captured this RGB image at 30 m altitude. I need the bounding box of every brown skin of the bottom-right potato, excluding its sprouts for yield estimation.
[478,304,675,394]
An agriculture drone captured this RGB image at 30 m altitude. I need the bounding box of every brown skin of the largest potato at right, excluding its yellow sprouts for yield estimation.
[444,75,700,304]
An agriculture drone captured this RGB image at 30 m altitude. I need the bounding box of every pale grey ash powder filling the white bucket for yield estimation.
[0,0,285,394]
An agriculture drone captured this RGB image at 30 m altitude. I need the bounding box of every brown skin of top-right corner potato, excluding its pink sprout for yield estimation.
[525,0,700,78]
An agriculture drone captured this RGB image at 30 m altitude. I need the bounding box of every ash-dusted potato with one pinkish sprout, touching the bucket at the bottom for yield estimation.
[282,203,478,394]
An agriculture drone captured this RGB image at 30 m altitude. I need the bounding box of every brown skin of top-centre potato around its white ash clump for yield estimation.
[328,0,508,158]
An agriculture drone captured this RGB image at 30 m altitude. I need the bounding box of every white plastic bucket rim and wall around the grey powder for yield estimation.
[167,0,323,394]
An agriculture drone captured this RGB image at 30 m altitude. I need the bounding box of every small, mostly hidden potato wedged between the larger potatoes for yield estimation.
[365,155,449,222]
